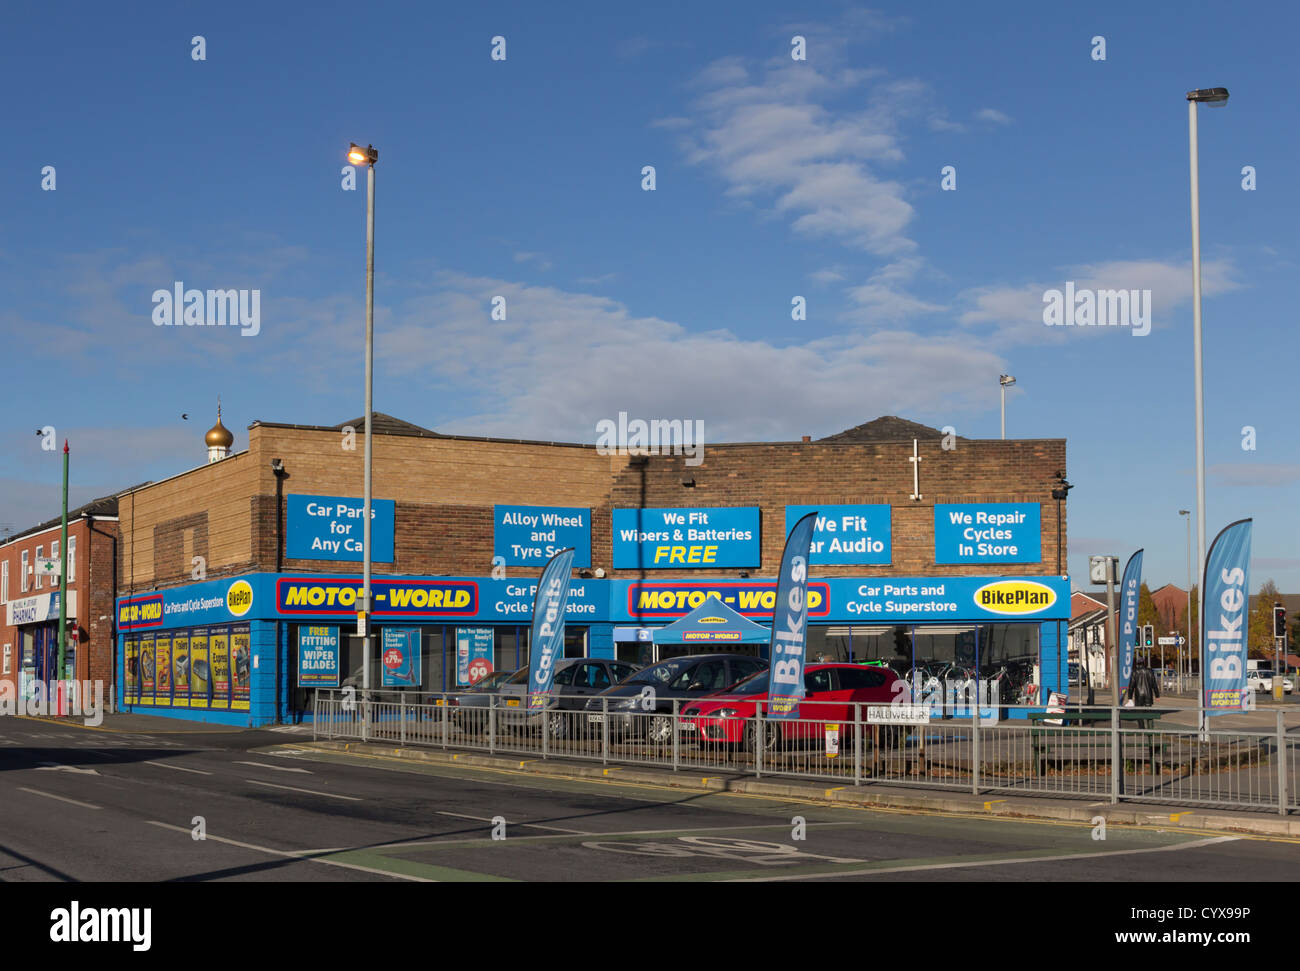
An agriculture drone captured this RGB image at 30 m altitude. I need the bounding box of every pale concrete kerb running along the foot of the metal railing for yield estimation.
[294,741,1300,837]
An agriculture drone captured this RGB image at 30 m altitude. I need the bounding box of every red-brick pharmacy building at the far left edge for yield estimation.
[0,497,117,697]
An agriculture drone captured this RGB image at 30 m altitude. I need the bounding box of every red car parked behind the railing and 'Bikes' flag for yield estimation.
[681,664,911,749]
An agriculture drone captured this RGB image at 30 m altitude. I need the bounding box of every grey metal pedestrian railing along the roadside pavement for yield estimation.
[312,690,1300,815]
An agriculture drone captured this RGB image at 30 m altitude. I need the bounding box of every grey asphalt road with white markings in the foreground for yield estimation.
[0,718,1300,884]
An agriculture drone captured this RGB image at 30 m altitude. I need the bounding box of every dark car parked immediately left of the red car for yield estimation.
[586,654,767,742]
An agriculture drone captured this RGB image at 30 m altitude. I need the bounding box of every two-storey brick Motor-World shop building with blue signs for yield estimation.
[118,415,1069,724]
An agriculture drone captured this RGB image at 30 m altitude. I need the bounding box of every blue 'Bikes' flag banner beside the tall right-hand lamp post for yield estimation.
[1201,519,1251,715]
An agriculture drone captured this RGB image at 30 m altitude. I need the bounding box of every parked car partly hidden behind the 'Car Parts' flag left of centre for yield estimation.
[452,658,640,737]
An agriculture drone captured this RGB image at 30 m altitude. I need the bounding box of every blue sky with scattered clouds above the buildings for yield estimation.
[0,1,1300,591]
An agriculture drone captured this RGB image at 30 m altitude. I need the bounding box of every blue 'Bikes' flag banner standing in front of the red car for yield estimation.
[767,511,816,719]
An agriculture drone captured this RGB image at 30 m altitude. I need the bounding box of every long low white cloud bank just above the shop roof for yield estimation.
[378,273,1004,442]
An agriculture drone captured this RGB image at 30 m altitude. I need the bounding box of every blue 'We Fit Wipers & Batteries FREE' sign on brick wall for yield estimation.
[612,506,762,569]
